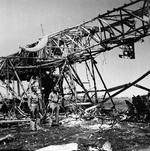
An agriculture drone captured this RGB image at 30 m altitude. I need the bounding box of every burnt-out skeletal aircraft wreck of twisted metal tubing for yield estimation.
[0,0,150,118]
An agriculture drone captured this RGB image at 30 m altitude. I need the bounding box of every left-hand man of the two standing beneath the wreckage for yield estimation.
[28,85,41,130]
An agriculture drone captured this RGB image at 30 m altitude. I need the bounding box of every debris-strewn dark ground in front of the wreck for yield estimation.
[0,117,150,151]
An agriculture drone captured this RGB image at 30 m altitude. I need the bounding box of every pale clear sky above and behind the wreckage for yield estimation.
[0,0,150,96]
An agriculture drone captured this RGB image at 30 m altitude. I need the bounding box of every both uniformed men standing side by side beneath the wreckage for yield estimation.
[28,85,60,131]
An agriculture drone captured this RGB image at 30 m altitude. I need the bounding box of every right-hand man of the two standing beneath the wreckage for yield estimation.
[48,87,61,126]
